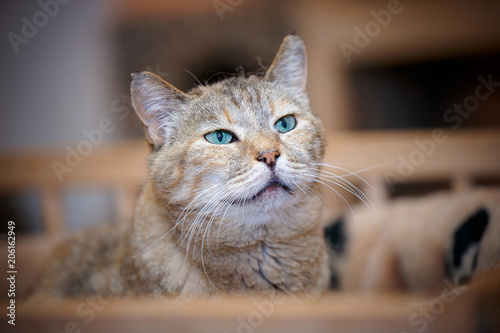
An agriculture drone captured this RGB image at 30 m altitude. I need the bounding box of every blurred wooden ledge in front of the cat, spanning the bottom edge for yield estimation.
[0,270,500,333]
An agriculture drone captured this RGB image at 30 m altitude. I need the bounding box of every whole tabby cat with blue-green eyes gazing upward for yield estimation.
[37,35,329,297]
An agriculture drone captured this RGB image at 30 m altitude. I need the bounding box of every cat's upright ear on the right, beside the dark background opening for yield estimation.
[264,35,307,92]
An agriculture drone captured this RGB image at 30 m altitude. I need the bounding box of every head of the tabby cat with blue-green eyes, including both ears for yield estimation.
[131,36,324,231]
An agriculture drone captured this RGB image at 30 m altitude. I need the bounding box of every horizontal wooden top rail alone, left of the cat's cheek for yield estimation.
[0,139,148,190]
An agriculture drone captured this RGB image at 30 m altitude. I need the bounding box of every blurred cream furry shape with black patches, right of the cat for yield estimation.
[325,188,500,293]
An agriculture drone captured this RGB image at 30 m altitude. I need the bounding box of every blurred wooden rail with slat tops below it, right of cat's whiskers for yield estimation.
[325,129,500,200]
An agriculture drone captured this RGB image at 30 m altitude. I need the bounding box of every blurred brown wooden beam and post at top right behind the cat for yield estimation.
[289,0,500,130]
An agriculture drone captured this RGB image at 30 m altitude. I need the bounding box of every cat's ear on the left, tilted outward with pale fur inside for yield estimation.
[130,72,186,147]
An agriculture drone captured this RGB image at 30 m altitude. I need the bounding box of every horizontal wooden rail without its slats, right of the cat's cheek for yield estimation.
[325,130,500,181]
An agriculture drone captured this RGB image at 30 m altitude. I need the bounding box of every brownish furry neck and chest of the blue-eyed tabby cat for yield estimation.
[133,184,328,291]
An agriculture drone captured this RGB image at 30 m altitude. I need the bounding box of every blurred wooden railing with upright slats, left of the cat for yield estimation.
[0,140,148,299]
